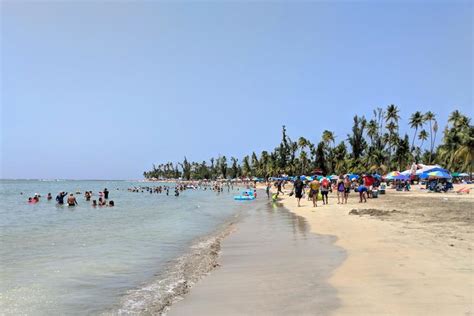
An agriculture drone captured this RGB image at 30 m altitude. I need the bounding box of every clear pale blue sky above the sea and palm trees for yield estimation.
[0,0,474,179]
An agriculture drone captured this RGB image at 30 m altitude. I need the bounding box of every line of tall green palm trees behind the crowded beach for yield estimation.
[143,104,474,180]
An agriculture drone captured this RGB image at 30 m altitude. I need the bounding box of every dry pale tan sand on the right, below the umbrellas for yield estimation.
[281,188,474,315]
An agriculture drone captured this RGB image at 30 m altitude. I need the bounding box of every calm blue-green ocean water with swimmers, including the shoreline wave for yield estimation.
[0,180,256,315]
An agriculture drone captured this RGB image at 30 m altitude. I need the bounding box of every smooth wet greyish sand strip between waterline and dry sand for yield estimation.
[167,199,346,315]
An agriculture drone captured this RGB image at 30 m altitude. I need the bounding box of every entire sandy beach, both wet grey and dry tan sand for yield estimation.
[165,185,474,315]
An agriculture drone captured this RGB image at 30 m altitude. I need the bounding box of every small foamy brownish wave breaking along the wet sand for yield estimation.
[103,223,234,315]
